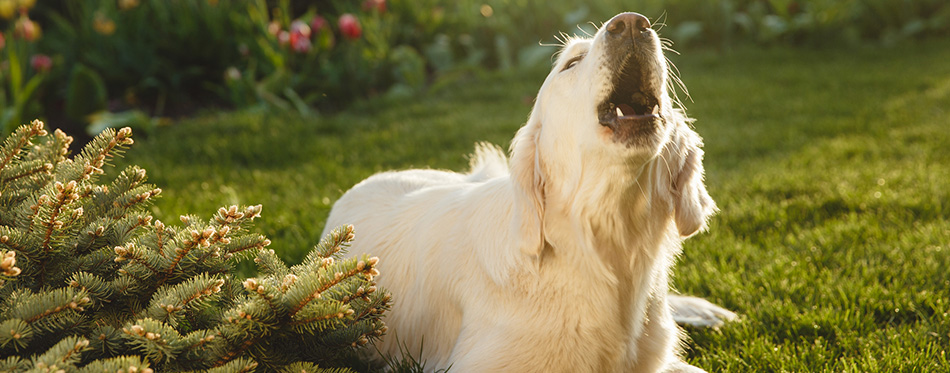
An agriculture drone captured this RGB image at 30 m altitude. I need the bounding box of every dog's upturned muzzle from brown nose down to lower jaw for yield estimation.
[597,13,661,141]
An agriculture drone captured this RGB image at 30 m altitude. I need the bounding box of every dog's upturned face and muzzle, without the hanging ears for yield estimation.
[533,13,673,157]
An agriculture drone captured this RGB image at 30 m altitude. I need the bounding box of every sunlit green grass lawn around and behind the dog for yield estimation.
[115,41,950,372]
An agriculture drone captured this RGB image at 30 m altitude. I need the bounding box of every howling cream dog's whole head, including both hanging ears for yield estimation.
[512,13,715,256]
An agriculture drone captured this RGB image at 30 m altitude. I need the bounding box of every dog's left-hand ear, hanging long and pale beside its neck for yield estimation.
[510,115,545,258]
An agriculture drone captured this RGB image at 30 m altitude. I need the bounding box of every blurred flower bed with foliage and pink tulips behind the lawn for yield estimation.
[0,0,950,143]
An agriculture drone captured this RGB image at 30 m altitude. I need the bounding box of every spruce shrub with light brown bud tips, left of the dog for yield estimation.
[0,121,391,372]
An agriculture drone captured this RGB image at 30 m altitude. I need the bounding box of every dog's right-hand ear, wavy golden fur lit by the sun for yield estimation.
[657,117,717,237]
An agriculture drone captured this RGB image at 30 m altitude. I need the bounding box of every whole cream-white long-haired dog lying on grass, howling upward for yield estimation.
[327,13,733,372]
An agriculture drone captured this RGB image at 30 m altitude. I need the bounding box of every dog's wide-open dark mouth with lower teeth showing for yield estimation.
[597,60,660,130]
